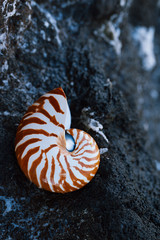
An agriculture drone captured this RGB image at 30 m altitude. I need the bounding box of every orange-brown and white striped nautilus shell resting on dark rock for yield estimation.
[15,88,100,193]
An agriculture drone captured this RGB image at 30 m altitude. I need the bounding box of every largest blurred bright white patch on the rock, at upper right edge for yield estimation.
[132,26,156,71]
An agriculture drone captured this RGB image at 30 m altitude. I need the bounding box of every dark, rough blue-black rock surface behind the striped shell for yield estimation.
[0,0,160,240]
